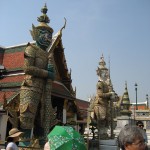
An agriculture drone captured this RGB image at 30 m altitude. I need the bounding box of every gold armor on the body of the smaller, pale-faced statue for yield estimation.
[94,81,111,120]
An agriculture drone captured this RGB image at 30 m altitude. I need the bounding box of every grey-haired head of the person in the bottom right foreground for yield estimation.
[118,125,146,150]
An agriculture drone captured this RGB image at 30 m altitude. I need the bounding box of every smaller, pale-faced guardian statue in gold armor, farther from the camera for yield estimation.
[91,56,115,139]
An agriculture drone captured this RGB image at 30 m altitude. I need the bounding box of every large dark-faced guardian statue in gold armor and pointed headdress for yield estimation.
[19,5,55,142]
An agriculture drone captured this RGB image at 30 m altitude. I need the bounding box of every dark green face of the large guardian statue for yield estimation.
[36,30,52,49]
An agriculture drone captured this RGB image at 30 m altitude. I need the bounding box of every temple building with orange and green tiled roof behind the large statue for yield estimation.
[0,5,88,146]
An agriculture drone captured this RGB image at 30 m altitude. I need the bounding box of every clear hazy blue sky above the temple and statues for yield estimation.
[0,0,150,102]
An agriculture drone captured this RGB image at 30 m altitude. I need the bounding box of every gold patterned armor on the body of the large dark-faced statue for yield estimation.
[19,44,48,129]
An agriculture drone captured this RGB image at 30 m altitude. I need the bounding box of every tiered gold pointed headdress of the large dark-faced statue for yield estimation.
[30,4,53,40]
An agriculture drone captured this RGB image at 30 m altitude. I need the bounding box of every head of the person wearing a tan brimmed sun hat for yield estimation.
[7,128,23,142]
